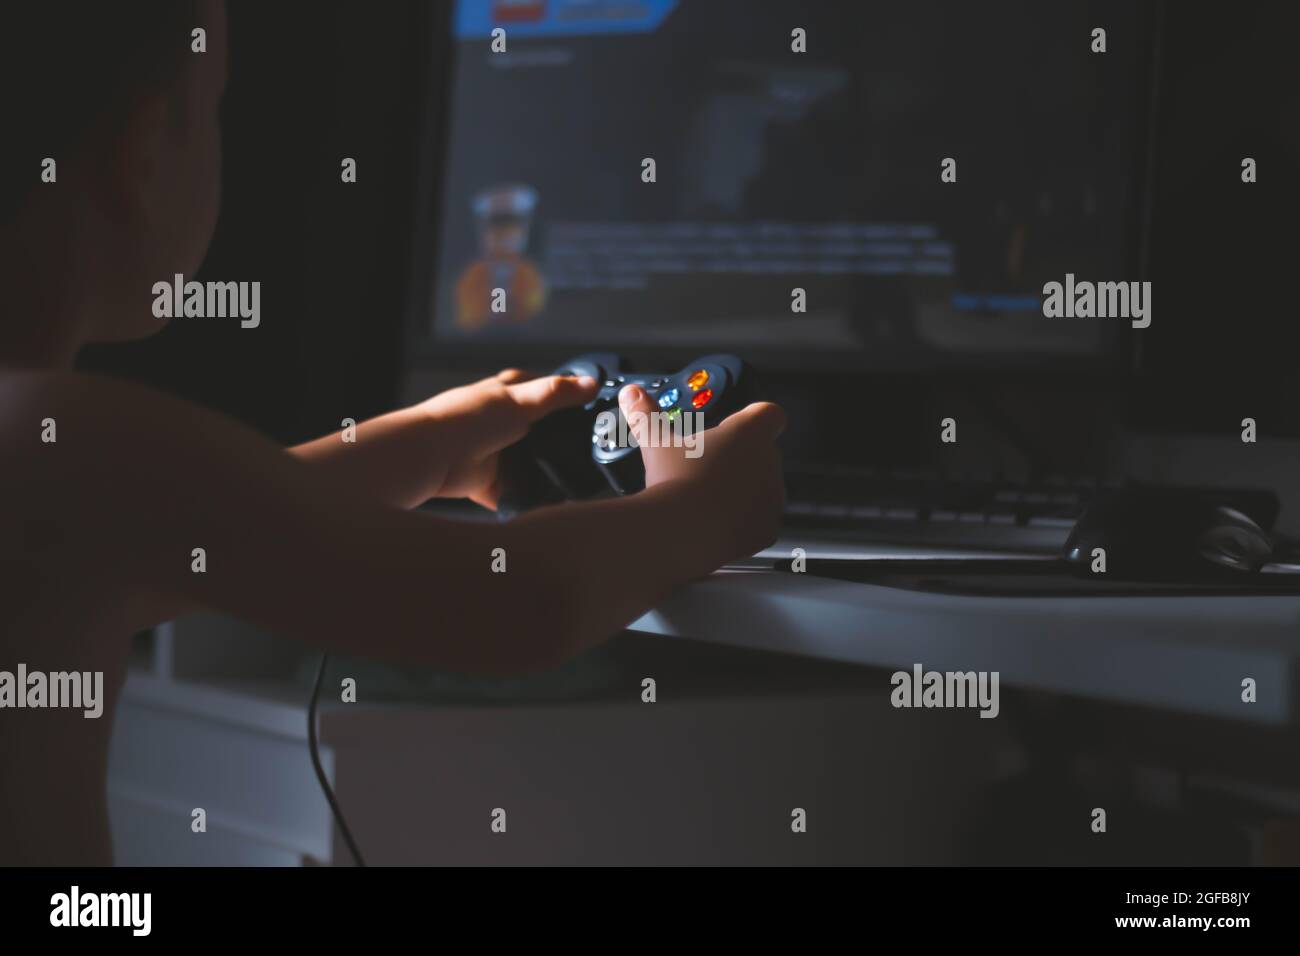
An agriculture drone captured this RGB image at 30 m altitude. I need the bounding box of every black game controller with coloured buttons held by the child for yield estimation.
[497,352,754,518]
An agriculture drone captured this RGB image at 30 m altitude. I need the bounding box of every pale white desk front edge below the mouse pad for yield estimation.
[631,571,1300,724]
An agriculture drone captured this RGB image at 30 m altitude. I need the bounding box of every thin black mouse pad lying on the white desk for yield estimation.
[775,559,1300,597]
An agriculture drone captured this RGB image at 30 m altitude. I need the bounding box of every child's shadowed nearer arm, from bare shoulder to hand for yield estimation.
[12,375,781,672]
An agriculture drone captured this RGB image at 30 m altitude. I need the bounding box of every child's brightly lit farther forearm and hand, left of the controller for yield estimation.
[289,369,597,507]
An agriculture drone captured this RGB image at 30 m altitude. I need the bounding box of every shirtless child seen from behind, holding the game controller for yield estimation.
[0,0,784,864]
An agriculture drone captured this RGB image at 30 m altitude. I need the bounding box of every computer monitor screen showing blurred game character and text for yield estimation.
[411,0,1154,372]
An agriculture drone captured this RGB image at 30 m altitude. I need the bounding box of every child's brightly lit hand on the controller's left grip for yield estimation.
[420,368,597,509]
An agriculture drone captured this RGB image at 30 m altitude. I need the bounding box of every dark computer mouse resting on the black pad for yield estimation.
[1062,485,1274,581]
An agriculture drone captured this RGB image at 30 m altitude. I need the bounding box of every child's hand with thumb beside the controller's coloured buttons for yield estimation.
[619,385,785,563]
